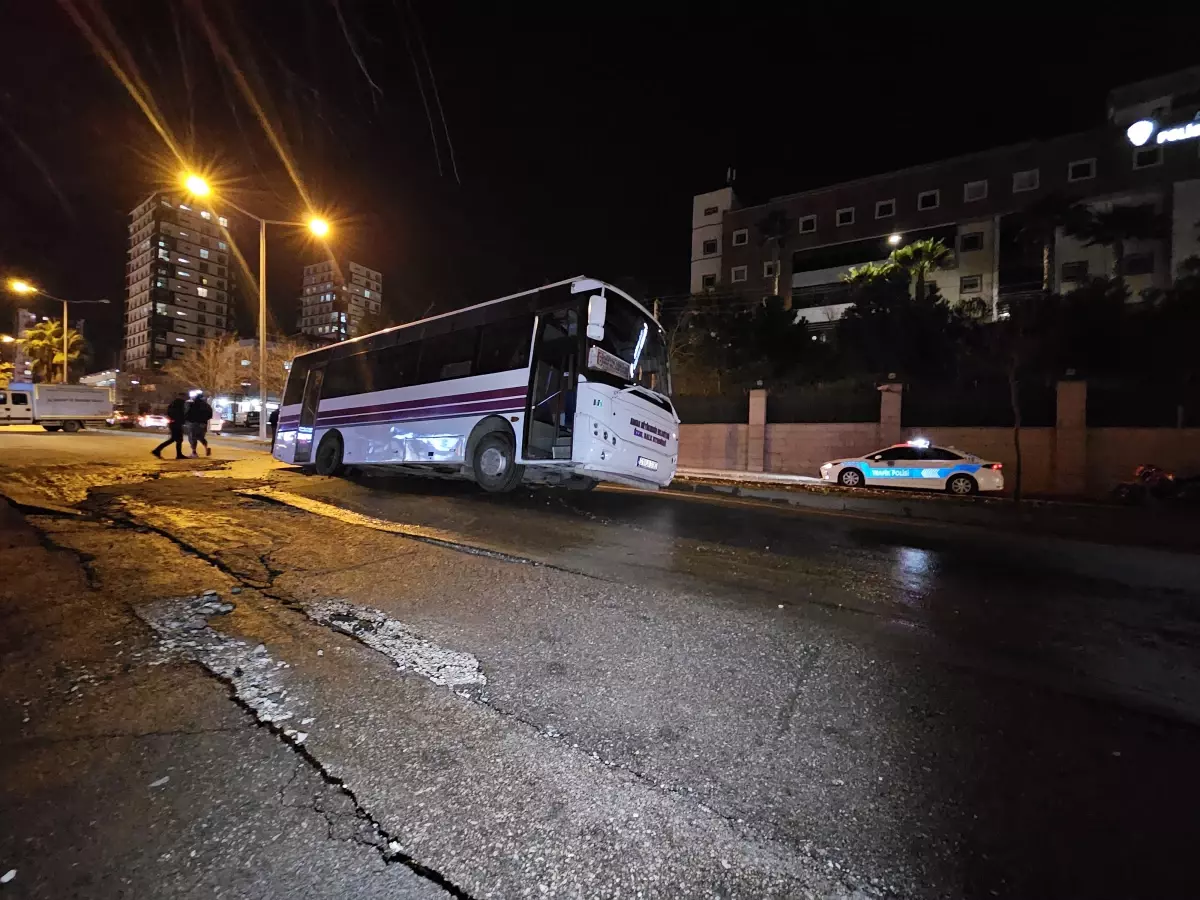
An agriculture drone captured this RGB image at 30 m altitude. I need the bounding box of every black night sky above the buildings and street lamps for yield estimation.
[0,0,1200,368]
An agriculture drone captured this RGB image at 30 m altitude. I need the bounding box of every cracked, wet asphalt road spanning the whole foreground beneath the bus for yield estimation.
[0,433,1200,898]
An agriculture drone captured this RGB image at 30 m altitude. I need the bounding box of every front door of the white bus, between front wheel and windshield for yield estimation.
[524,310,580,460]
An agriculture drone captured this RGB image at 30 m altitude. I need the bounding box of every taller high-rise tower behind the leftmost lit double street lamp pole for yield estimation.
[122,191,233,370]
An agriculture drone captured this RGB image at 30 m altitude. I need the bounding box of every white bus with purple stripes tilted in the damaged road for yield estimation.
[272,276,679,492]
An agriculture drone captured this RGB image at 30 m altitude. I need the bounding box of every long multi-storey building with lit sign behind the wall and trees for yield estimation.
[690,67,1200,326]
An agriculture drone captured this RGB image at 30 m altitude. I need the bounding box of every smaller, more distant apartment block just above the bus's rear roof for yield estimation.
[300,259,383,341]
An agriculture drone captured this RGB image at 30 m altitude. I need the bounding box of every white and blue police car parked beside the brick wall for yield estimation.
[821,438,1004,497]
